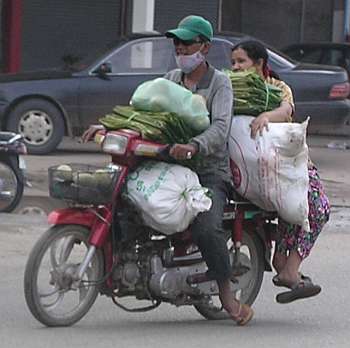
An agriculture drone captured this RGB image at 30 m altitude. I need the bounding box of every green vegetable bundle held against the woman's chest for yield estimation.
[225,70,282,116]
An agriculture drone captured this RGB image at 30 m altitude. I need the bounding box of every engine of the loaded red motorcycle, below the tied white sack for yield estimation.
[113,200,216,302]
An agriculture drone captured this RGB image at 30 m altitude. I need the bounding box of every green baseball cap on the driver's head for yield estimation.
[165,16,213,41]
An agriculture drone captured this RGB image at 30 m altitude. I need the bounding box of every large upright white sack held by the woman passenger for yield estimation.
[229,116,310,231]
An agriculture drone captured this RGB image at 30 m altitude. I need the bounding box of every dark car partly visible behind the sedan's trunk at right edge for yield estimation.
[281,42,350,76]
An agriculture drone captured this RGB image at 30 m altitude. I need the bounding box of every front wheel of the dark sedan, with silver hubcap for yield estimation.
[7,99,65,155]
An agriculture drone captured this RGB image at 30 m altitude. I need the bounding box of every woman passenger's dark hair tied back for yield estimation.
[232,40,280,80]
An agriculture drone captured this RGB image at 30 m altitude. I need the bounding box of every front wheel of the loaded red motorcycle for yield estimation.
[24,225,104,326]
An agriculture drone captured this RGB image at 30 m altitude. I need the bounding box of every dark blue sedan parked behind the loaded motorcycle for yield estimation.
[0,35,350,154]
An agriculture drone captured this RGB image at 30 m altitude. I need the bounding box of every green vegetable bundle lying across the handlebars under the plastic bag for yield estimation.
[99,106,194,145]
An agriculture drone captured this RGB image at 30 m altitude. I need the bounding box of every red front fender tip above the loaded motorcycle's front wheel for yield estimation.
[48,208,96,227]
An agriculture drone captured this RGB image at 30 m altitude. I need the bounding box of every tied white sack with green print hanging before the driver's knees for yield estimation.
[127,161,212,235]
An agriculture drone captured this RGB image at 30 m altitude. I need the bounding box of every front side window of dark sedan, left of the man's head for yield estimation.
[104,38,174,74]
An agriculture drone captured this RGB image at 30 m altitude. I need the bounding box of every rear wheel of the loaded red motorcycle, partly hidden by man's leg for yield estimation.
[194,232,265,320]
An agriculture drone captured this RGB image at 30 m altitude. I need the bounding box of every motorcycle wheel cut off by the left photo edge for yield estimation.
[0,157,24,213]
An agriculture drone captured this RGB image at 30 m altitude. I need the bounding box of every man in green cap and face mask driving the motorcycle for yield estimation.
[83,16,253,325]
